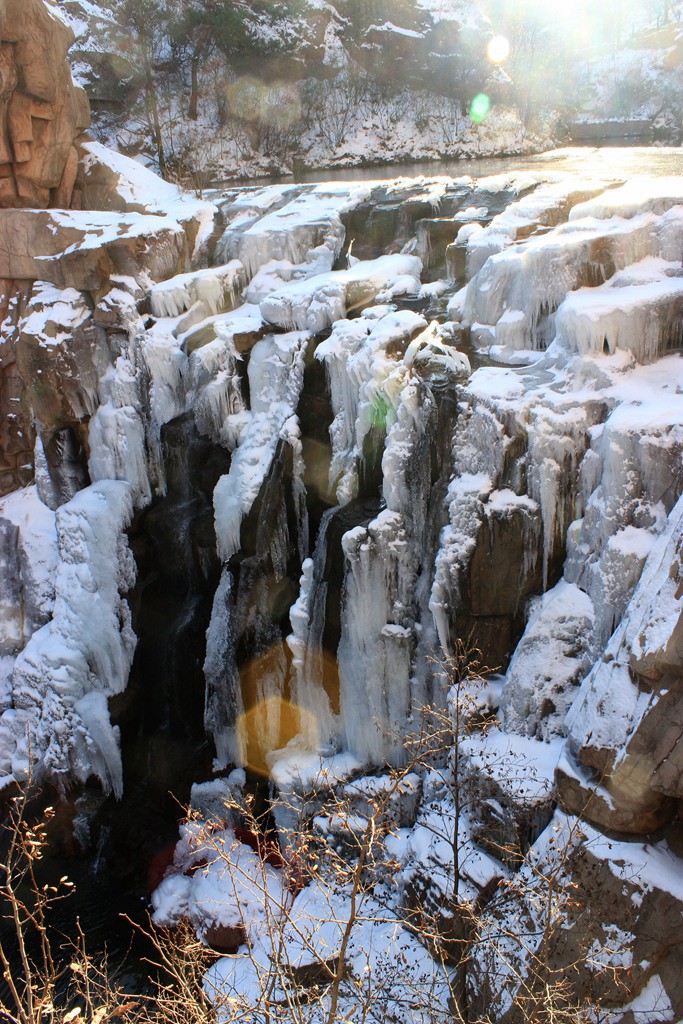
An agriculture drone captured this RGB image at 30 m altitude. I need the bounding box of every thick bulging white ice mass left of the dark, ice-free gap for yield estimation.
[0,480,135,795]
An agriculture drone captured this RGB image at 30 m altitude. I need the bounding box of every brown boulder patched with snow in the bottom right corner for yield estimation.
[468,812,683,1024]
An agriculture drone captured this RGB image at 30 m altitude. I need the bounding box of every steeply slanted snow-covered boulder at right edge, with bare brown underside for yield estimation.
[558,491,683,833]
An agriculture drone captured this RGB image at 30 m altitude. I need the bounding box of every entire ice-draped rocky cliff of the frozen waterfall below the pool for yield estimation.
[0,7,683,1024]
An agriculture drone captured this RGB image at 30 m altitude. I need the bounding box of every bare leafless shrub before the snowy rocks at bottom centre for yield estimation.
[141,641,634,1024]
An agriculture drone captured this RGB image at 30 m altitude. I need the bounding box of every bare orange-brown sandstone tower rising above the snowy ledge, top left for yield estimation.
[0,0,90,208]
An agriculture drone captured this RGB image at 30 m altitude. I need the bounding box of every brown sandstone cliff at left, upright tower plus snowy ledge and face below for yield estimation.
[0,0,215,497]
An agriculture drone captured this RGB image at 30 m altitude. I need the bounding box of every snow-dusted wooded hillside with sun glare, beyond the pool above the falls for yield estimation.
[60,0,681,180]
